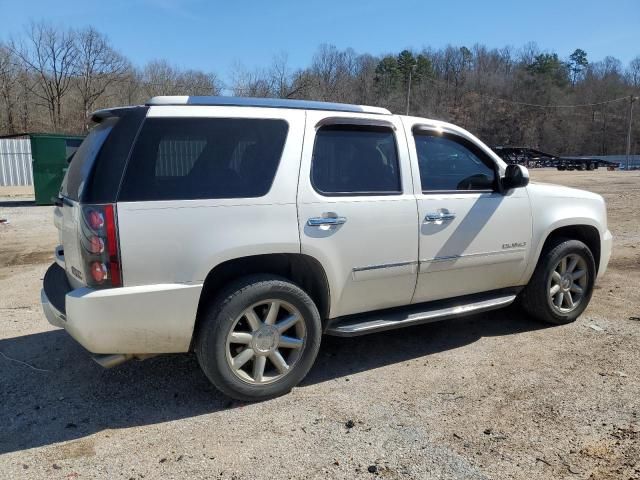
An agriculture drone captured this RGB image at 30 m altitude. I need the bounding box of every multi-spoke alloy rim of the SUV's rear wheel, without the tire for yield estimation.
[226,299,307,385]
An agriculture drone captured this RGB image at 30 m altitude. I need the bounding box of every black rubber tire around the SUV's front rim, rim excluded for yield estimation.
[519,238,596,325]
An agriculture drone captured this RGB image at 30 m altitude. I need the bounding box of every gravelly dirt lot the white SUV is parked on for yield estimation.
[0,171,640,479]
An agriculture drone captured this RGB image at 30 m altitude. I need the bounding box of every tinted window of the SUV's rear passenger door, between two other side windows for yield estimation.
[311,125,401,195]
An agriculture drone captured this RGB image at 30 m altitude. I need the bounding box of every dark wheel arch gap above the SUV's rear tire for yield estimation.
[191,253,331,347]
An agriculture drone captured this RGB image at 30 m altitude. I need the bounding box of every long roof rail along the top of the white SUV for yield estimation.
[146,95,391,115]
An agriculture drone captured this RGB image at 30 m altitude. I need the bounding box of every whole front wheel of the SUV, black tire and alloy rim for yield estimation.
[520,239,596,325]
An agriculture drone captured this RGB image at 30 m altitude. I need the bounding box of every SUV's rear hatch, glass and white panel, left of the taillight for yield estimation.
[54,117,118,288]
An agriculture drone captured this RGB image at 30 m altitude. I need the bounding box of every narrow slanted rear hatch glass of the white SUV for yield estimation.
[60,117,118,201]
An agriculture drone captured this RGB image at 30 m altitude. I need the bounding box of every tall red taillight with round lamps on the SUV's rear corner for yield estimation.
[80,204,122,288]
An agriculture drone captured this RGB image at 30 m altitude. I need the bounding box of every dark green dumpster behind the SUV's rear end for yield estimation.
[29,133,84,205]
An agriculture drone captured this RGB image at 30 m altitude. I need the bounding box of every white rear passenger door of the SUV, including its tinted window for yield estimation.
[298,111,418,317]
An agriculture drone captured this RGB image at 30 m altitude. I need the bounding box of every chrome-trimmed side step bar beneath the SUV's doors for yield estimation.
[325,293,516,337]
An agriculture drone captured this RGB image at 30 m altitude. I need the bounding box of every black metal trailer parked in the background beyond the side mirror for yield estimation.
[492,146,620,171]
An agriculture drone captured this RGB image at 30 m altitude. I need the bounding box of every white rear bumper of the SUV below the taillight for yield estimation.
[40,264,202,354]
